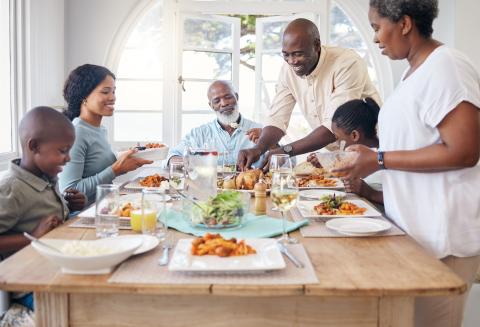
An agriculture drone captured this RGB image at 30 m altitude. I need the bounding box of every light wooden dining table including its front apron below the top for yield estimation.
[0,192,466,327]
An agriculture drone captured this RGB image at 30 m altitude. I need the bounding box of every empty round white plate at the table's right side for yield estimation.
[325,218,392,236]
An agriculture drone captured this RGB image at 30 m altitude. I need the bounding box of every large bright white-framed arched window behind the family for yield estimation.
[111,0,392,149]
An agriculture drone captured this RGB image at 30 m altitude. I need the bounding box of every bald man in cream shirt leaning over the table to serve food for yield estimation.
[237,18,381,170]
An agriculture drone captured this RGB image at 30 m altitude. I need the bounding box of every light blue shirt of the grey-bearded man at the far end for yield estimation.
[167,116,263,167]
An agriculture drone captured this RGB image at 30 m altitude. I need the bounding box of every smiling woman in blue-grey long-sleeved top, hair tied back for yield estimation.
[59,64,151,203]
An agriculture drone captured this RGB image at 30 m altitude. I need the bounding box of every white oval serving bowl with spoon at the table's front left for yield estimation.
[32,237,143,275]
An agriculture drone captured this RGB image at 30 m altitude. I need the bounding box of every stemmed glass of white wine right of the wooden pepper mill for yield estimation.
[271,171,298,244]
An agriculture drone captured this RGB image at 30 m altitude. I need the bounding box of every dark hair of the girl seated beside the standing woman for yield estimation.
[332,98,380,138]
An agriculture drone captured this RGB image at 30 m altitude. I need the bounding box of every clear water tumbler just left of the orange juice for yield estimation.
[95,184,120,238]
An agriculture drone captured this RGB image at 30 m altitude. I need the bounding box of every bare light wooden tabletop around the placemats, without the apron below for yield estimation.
[0,199,466,296]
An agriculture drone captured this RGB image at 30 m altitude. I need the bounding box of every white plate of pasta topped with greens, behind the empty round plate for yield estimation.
[297,193,382,218]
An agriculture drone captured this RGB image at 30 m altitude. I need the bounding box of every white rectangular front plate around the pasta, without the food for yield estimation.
[168,238,286,272]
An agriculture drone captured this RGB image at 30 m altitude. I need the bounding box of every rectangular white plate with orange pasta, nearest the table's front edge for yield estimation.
[168,234,286,273]
